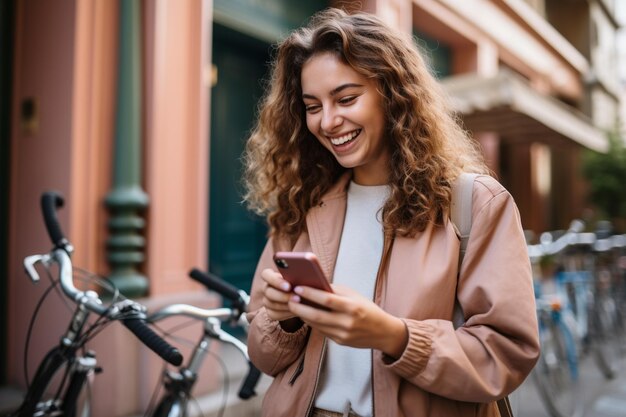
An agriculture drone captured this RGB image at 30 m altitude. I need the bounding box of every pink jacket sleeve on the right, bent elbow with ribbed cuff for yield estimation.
[386,177,539,402]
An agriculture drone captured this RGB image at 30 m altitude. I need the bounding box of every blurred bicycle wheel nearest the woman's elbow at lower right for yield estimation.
[532,314,580,417]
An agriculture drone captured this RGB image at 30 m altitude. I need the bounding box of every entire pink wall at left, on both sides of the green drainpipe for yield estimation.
[7,0,217,417]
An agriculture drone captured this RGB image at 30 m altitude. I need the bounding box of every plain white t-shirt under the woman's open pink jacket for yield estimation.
[315,182,389,417]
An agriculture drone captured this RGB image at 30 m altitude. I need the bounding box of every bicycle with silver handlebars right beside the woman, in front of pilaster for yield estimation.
[145,269,261,417]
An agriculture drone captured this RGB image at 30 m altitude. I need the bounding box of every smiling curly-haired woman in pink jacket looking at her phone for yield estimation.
[245,9,539,417]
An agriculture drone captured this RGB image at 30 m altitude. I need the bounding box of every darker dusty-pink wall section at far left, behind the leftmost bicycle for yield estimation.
[8,0,76,383]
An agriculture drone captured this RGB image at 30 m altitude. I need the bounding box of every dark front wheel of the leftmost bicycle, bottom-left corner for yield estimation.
[13,347,91,417]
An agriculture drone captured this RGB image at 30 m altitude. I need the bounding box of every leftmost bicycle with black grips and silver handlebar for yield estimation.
[11,192,183,417]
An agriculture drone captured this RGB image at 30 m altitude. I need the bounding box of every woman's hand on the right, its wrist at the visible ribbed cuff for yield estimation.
[288,285,408,359]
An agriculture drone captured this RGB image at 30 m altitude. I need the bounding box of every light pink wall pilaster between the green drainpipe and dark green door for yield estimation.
[145,0,212,295]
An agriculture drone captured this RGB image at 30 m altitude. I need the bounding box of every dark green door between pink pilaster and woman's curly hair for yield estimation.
[209,24,269,291]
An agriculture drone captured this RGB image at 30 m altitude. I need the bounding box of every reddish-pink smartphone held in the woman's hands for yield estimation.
[274,252,333,310]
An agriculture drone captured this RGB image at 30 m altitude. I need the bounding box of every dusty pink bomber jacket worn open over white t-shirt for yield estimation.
[248,176,539,417]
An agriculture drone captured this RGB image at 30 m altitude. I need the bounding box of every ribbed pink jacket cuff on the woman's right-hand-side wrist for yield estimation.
[383,319,428,379]
